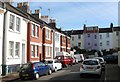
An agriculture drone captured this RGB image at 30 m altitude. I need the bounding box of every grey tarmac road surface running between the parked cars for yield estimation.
[11,63,105,82]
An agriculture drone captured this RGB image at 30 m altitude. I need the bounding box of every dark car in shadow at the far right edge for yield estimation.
[103,54,118,64]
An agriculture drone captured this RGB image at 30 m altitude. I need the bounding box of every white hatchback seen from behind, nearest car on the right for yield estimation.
[80,59,102,77]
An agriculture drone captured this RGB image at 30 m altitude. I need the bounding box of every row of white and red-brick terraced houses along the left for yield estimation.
[0,2,70,74]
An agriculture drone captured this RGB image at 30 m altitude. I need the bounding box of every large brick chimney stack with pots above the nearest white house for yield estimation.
[17,2,30,13]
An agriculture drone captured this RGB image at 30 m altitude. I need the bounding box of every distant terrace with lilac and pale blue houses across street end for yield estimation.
[64,23,120,51]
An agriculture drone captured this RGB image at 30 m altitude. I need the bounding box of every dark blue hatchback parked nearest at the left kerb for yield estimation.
[19,62,52,80]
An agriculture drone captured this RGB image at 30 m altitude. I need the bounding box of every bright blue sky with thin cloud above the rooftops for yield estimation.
[11,0,118,30]
